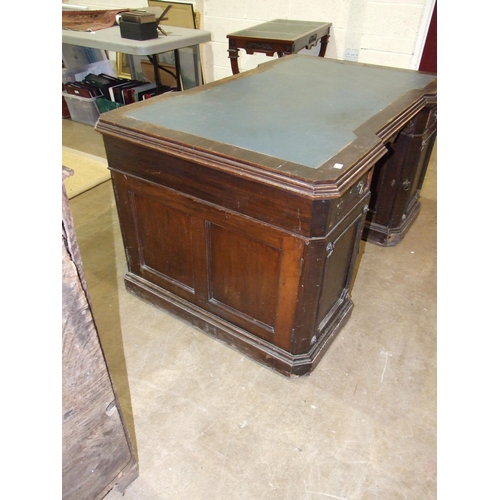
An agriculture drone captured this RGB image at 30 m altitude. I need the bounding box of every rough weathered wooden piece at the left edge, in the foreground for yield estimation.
[62,169,138,500]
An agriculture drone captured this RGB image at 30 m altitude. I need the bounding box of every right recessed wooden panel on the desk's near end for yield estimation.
[209,224,281,328]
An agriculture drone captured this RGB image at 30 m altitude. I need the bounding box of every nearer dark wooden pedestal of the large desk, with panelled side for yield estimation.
[104,136,372,376]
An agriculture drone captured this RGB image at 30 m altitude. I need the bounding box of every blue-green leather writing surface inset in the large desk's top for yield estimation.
[123,55,436,169]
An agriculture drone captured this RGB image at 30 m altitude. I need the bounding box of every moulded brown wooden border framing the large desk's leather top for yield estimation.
[96,55,437,199]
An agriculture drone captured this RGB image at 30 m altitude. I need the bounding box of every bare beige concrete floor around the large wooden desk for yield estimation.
[63,120,437,500]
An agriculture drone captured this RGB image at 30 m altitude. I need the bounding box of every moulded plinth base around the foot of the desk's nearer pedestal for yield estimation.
[125,272,353,377]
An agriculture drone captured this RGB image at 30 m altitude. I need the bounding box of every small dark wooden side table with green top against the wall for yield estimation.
[227,19,332,75]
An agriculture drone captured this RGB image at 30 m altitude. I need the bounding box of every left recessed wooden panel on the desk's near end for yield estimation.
[134,195,194,288]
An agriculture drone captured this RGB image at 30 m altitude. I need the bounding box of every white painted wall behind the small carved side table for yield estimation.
[63,0,435,82]
